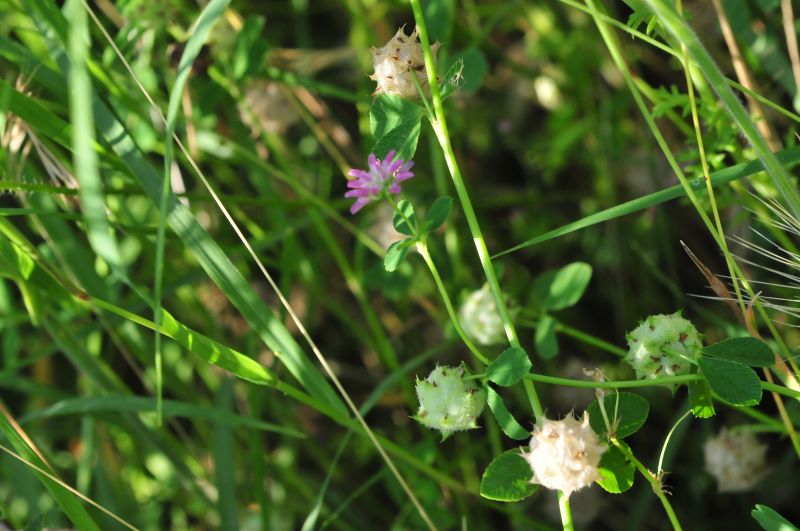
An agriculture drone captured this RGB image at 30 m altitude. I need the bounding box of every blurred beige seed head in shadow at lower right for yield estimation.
[703,428,767,492]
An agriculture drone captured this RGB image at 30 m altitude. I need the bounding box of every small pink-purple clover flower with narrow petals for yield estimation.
[344,150,414,214]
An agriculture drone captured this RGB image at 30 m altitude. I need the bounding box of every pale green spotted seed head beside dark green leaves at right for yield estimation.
[625,311,703,379]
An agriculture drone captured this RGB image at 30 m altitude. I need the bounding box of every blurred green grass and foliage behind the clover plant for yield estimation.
[0,0,800,529]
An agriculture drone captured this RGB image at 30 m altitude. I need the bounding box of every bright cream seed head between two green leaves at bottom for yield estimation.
[522,412,606,497]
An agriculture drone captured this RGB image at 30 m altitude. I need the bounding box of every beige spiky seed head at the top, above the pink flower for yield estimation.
[370,27,439,99]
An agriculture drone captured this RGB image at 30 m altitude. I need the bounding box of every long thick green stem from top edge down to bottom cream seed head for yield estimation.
[410,0,544,423]
